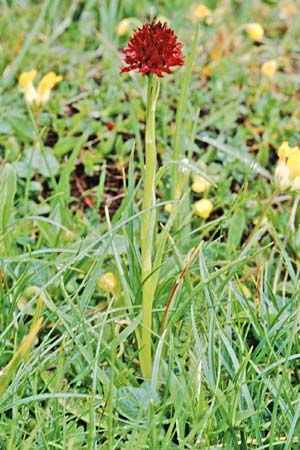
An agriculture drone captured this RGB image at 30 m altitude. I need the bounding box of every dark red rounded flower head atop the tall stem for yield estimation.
[121,22,184,78]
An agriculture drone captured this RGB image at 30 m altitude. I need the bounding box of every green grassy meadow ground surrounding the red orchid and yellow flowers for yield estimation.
[0,0,300,450]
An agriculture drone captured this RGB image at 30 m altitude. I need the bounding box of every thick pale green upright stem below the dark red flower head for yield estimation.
[139,73,159,378]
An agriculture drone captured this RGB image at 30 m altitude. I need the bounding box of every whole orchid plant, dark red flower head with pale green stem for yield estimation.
[121,22,184,378]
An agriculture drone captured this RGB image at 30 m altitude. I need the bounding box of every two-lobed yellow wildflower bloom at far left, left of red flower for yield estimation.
[19,69,62,105]
